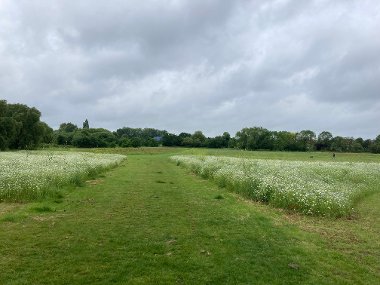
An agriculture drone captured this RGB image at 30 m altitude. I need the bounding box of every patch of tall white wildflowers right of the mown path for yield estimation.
[171,156,380,217]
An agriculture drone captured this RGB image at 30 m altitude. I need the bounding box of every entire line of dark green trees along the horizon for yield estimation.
[0,100,380,153]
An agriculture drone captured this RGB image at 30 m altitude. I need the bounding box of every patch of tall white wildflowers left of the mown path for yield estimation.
[0,151,125,202]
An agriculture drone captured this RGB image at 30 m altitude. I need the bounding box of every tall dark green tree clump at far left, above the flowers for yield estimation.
[0,100,53,150]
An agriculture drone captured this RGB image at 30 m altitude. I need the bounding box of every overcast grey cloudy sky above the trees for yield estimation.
[0,0,380,138]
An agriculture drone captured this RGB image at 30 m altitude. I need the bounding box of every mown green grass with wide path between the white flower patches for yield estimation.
[0,148,380,284]
